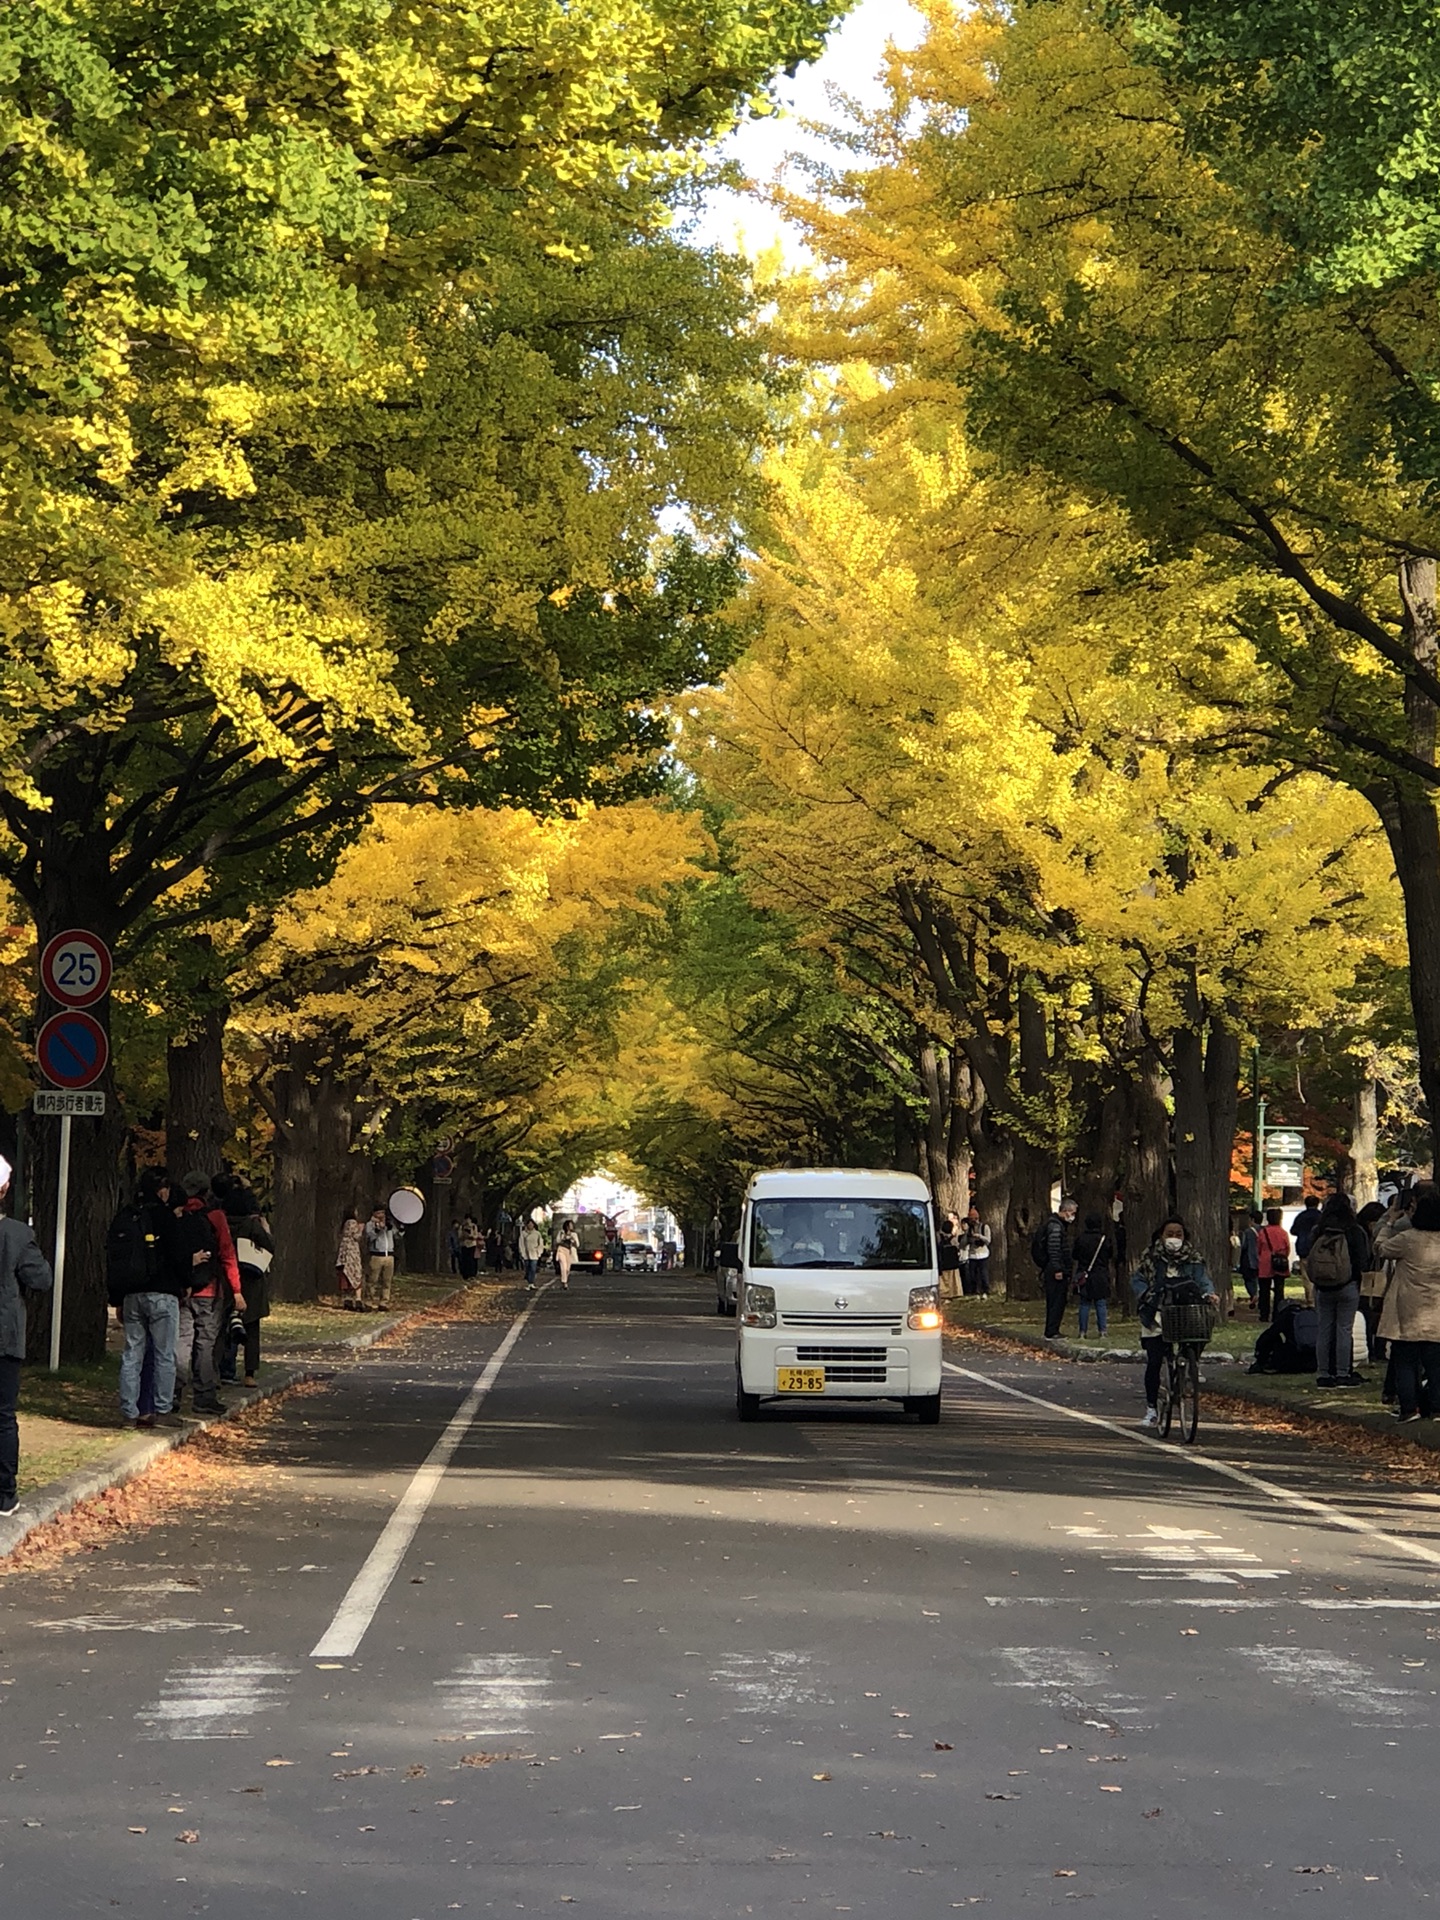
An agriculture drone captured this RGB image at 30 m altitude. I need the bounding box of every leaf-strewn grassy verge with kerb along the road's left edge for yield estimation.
[0,1275,503,1561]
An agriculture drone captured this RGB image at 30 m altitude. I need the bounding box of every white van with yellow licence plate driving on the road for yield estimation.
[735,1167,943,1425]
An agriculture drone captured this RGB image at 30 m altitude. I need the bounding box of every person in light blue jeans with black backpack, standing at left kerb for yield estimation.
[106,1169,180,1428]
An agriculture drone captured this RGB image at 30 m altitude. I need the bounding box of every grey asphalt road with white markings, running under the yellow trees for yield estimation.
[0,1277,1440,1920]
